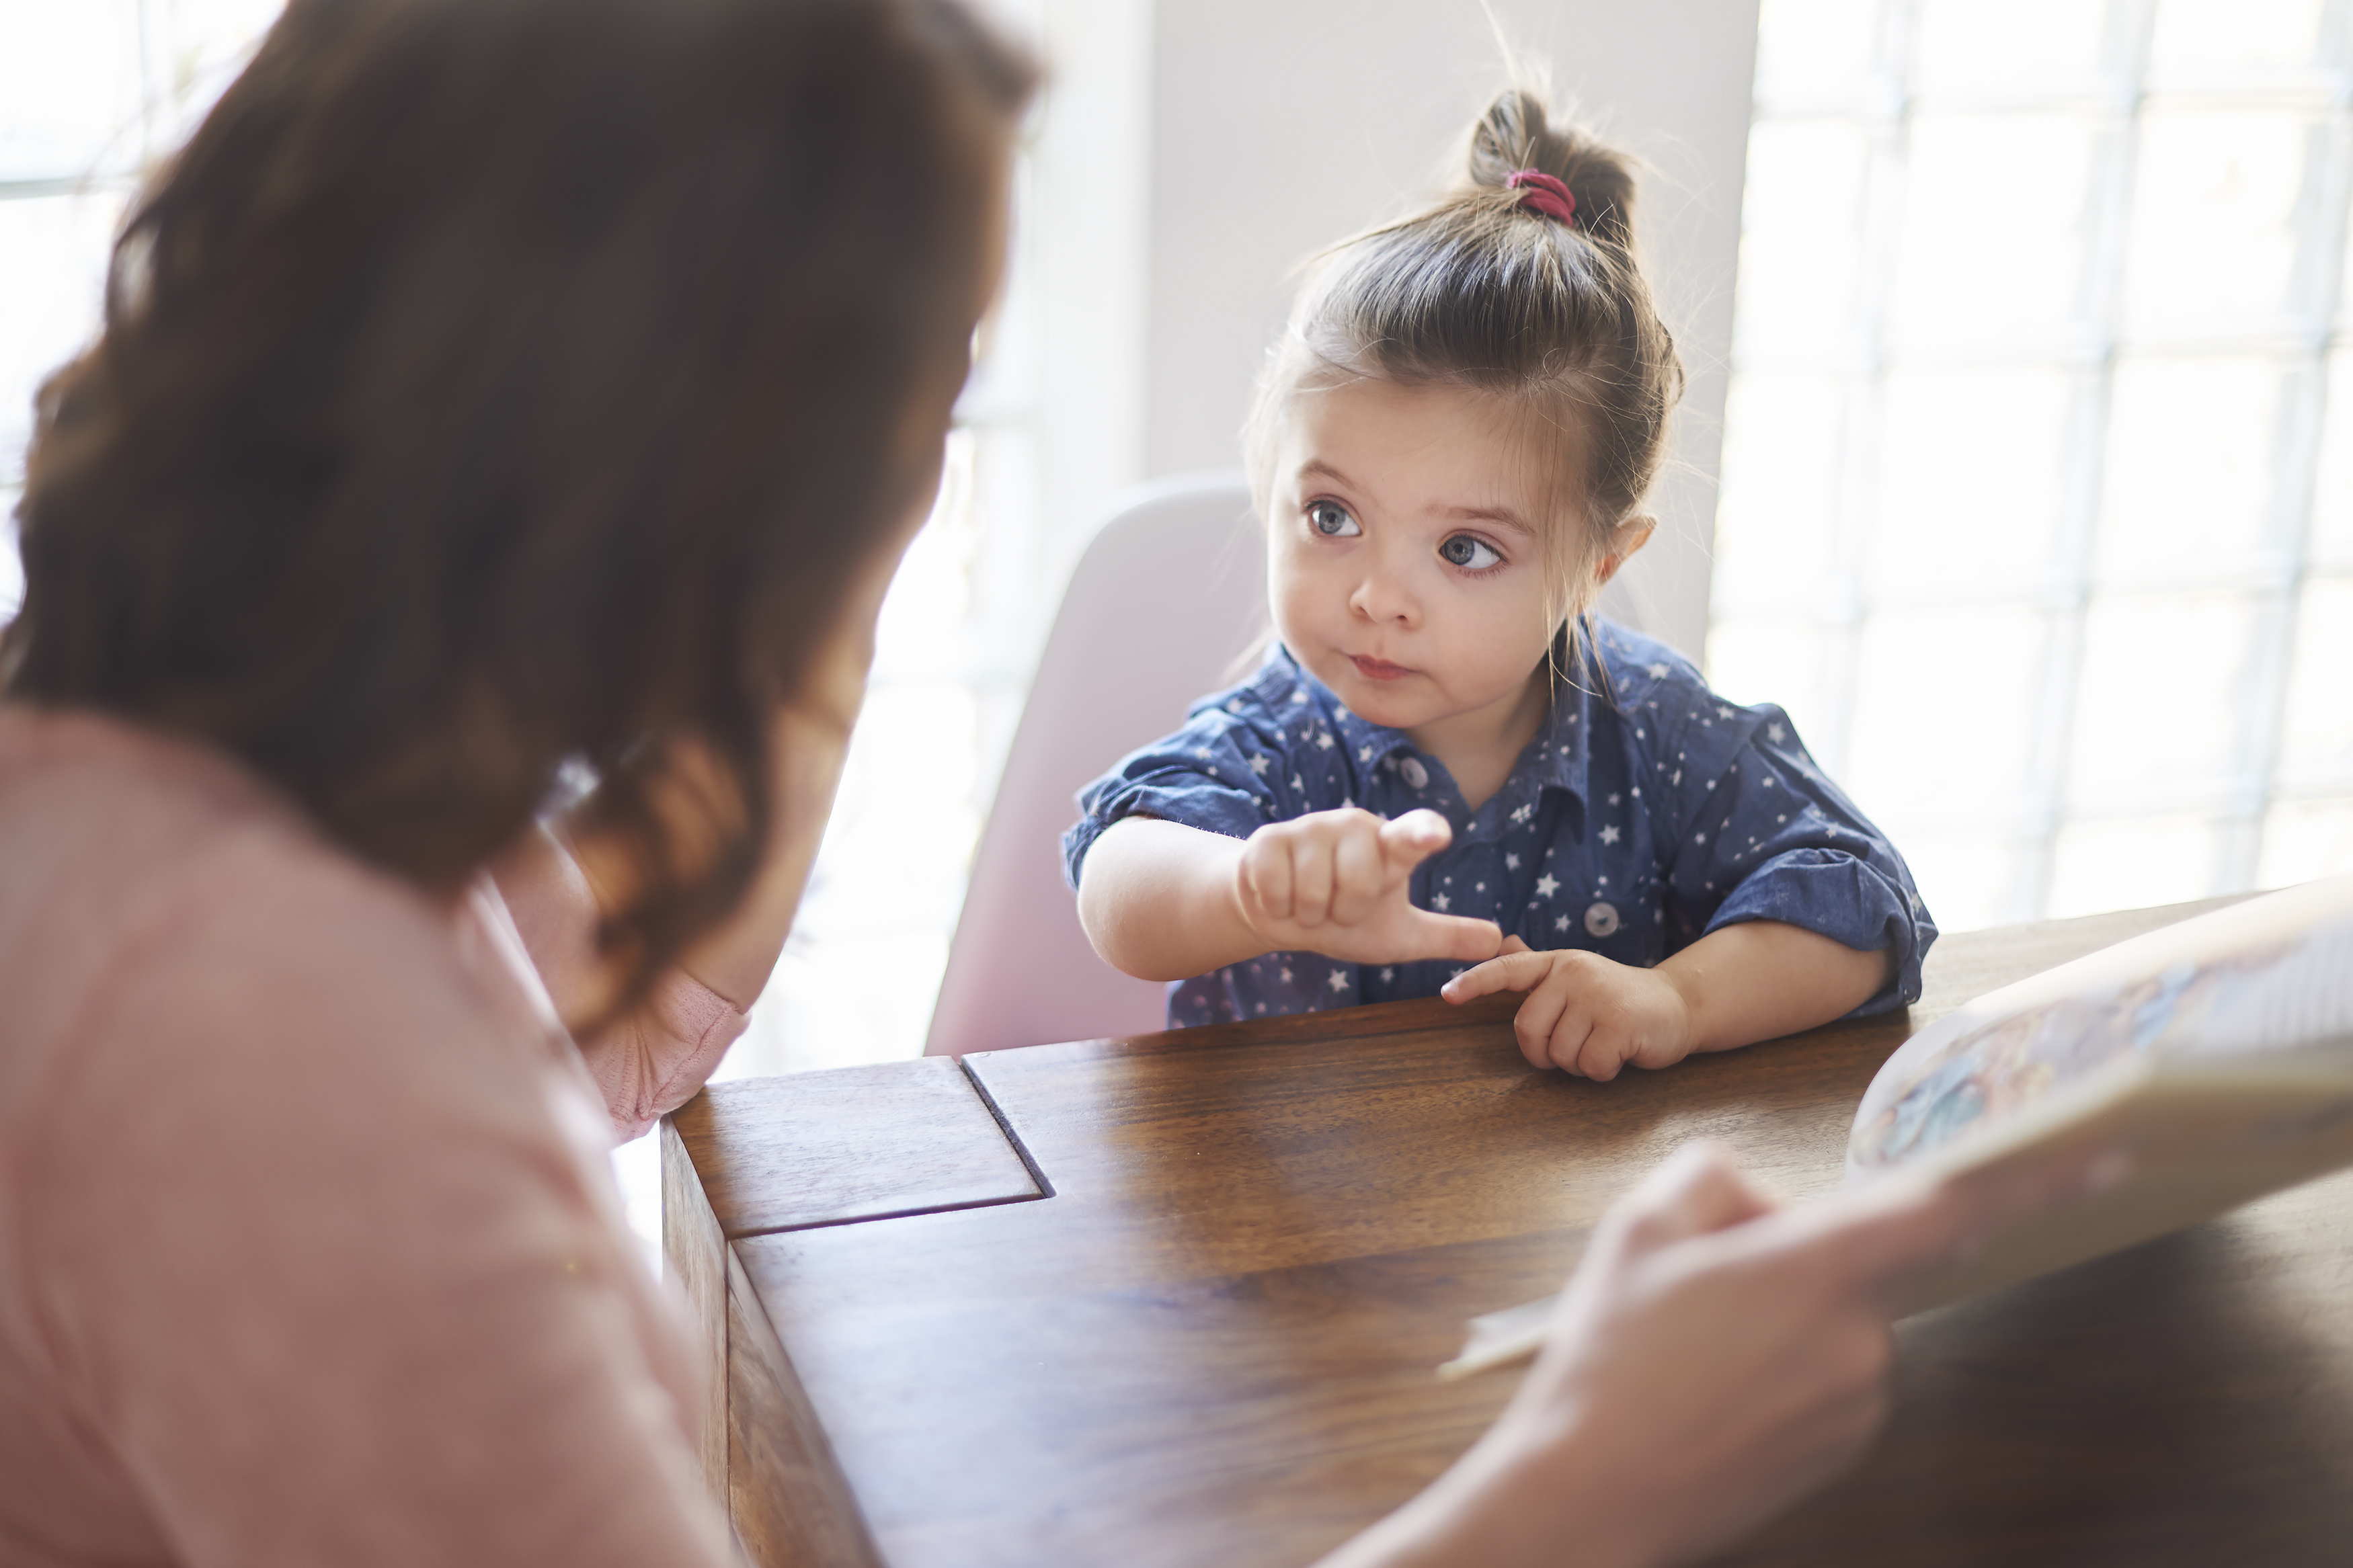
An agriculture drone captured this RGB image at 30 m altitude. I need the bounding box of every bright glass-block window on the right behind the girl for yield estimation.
[1708,0,2353,929]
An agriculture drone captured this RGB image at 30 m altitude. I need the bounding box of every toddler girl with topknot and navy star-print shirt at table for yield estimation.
[1064,89,1937,1079]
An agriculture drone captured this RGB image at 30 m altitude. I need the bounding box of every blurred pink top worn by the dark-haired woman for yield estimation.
[0,705,744,1568]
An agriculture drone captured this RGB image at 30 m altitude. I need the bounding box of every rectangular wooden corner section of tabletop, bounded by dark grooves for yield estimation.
[671,1058,1045,1239]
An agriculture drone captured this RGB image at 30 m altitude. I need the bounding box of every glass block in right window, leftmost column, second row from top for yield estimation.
[1737,120,1871,360]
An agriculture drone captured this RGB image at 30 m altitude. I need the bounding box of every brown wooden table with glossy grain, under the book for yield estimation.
[664,905,2353,1568]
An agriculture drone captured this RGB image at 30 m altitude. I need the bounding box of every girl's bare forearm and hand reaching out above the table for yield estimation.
[1078,809,1504,981]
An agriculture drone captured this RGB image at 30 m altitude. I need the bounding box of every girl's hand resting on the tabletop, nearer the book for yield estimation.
[1440,936,1692,1083]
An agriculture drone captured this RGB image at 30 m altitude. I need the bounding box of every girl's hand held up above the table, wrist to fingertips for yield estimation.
[1236,807,1504,964]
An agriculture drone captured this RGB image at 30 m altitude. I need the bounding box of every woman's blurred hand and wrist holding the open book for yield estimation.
[1325,1145,2094,1568]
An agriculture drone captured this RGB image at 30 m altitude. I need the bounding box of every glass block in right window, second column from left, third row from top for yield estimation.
[1871,367,2071,597]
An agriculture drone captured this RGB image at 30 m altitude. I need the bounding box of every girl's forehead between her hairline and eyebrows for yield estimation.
[1275,376,1584,522]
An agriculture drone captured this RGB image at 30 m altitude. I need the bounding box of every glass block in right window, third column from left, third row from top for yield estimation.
[2099,360,2282,583]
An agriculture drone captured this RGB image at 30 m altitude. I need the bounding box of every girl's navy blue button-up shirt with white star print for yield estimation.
[1062,620,1937,1028]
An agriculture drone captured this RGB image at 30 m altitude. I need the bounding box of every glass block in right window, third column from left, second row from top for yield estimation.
[2125,110,2323,336]
